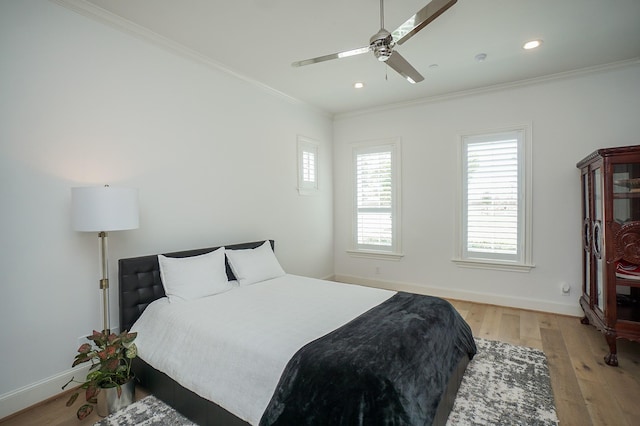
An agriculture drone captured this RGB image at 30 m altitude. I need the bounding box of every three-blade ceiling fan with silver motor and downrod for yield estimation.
[291,0,458,83]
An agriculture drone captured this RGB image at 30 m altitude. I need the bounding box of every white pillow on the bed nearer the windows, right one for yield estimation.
[226,241,285,286]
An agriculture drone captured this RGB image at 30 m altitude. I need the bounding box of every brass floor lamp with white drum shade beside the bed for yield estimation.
[71,185,139,334]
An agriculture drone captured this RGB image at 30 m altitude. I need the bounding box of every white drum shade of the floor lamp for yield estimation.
[71,186,139,232]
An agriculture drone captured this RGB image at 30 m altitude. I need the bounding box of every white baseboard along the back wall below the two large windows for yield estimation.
[334,275,584,317]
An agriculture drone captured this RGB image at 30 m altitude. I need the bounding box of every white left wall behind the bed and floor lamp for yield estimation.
[0,0,333,418]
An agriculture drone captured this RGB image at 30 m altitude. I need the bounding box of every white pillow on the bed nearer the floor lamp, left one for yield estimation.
[158,247,233,303]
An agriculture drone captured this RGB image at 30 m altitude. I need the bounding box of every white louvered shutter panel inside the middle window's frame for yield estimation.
[356,149,393,248]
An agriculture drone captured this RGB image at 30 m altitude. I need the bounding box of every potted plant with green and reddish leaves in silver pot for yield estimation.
[62,330,138,420]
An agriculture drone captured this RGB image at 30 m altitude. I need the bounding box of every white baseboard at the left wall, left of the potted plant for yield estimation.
[0,365,89,420]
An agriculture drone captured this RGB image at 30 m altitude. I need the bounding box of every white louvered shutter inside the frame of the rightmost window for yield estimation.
[465,134,520,258]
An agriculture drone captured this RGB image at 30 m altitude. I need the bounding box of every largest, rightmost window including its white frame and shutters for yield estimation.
[454,126,533,271]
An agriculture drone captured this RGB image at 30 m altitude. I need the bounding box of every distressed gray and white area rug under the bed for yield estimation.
[95,338,558,426]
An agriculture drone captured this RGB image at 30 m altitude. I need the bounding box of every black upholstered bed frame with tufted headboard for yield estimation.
[118,240,469,426]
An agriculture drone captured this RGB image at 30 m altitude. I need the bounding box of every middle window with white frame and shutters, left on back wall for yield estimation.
[351,141,400,258]
